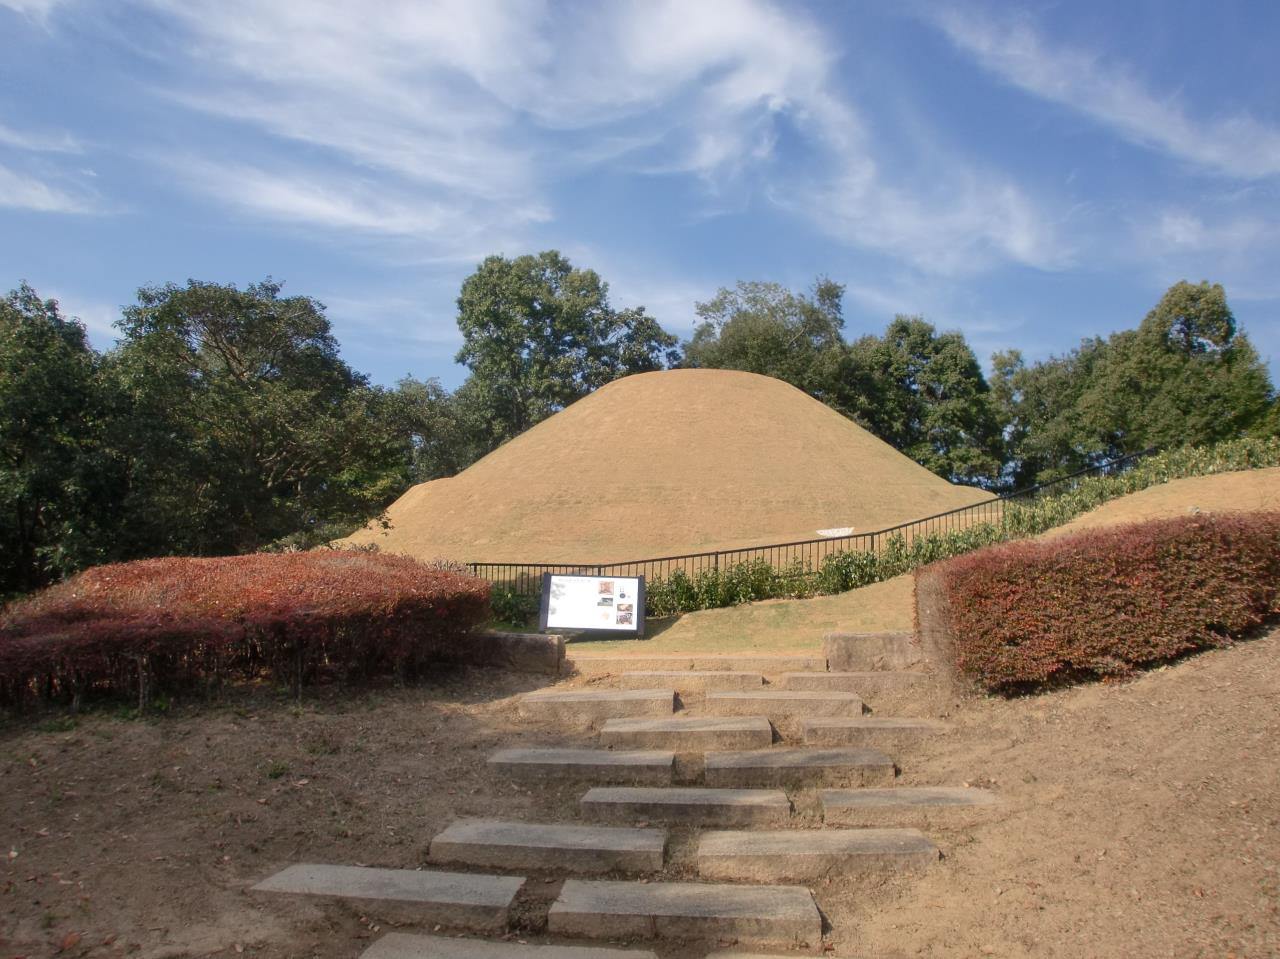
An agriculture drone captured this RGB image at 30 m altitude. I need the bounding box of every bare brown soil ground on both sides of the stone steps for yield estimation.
[0,631,1280,959]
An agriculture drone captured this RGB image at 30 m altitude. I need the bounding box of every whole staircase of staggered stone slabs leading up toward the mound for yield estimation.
[255,627,998,959]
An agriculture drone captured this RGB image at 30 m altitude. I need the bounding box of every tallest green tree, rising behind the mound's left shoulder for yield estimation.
[457,250,677,448]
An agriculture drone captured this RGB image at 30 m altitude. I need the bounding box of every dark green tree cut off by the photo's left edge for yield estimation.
[0,283,102,595]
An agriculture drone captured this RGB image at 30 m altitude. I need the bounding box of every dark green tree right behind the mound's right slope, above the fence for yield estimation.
[835,315,1004,487]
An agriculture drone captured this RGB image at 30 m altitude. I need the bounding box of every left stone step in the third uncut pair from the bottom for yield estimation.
[579,786,791,826]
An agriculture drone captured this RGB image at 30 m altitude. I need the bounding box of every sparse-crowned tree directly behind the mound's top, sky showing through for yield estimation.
[685,277,845,402]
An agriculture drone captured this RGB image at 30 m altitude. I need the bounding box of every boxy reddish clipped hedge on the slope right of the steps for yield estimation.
[938,512,1280,691]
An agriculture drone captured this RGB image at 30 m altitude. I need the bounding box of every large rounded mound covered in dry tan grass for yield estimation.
[348,370,988,562]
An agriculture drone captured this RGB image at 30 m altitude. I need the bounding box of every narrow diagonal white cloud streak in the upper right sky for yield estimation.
[936,6,1280,178]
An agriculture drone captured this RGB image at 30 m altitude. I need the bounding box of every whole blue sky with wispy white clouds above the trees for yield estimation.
[0,0,1280,387]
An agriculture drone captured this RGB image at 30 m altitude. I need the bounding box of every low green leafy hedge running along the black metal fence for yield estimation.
[645,437,1280,616]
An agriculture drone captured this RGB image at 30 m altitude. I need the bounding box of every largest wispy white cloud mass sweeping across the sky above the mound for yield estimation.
[17,0,1069,274]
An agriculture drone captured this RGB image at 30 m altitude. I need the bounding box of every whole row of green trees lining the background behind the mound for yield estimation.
[0,268,1280,595]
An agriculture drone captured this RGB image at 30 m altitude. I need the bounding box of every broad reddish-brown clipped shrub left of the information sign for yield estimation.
[0,551,489,707]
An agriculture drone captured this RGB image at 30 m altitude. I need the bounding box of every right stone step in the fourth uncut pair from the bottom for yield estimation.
[703,746,896,786]
